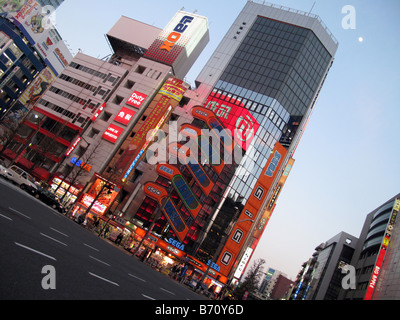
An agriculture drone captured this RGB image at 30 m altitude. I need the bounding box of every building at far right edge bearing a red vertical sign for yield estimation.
[339,194,400,300]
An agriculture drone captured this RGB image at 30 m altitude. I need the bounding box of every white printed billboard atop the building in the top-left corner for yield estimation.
[0,0,72,75]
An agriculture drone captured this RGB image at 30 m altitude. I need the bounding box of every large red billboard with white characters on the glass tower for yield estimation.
[204,93,260,151]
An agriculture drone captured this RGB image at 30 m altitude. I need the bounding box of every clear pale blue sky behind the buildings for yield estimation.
[56,0,400,279]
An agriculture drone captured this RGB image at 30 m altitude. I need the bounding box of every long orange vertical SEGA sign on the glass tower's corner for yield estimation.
[218,142,287,276]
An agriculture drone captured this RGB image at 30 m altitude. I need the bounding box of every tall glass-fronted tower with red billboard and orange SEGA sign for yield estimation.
[189,1,338,275]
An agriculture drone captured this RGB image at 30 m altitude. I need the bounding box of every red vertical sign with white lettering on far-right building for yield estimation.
[364,198,400,300]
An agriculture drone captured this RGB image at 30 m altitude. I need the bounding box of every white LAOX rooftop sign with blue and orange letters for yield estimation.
[144,11,208,65]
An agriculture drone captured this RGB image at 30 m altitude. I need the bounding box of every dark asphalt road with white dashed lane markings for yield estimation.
[0,179,203,300]
